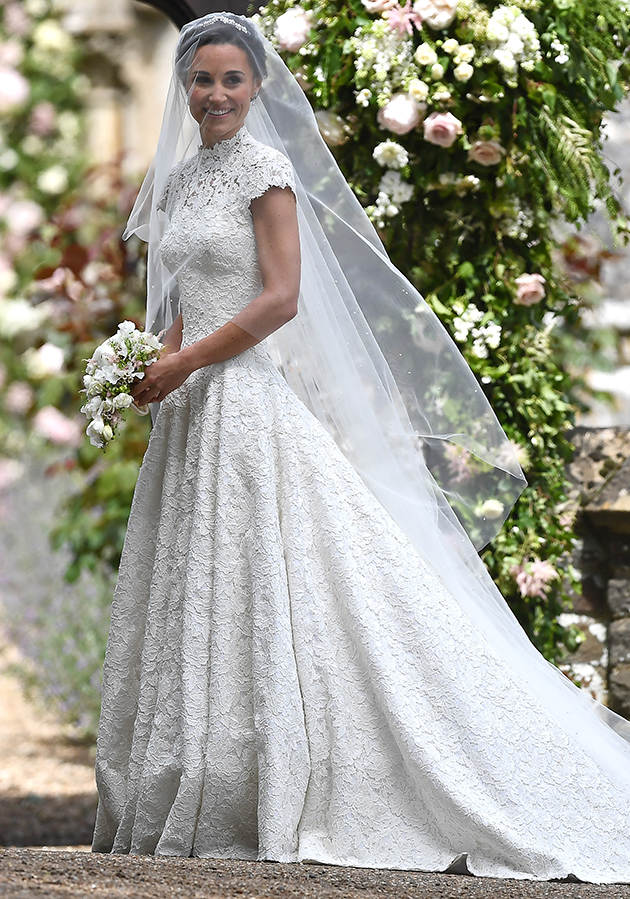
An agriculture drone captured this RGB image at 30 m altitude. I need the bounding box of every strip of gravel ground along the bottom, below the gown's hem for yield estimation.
[0,849,630,899]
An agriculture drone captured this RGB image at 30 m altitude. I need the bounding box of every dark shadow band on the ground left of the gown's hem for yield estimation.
[0,793,96,846]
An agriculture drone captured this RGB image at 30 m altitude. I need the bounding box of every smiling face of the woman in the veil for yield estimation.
[188,44,260,147]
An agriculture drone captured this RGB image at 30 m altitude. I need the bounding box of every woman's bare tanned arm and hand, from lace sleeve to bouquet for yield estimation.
[132,187,300,405]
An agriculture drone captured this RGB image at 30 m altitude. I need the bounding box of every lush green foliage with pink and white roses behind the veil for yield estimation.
[259,0,630,659]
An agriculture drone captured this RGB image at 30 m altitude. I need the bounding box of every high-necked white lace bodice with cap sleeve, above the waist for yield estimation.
[158,128,295,345]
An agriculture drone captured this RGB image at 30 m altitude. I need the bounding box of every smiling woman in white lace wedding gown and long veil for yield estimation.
[93,13,630,882]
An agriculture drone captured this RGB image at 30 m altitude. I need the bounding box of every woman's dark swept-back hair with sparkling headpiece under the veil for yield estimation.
[175,12,267,85]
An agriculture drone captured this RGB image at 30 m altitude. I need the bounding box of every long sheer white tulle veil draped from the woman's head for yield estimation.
[125,13,630,760]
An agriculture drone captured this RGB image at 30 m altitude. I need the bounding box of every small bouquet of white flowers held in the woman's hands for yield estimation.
[81,321,164,448]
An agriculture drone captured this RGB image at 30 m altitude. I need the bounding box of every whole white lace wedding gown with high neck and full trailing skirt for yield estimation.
[94,130,630,882]
